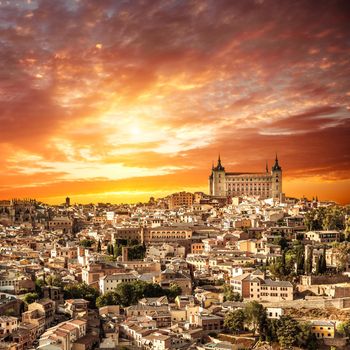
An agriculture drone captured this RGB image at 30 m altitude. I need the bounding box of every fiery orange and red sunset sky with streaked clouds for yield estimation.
[0,0,350,204]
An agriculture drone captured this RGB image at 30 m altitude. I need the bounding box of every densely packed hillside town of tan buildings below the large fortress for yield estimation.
[0,186,350,350]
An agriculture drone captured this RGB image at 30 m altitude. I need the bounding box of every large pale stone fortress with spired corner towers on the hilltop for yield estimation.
[209,155,282,199]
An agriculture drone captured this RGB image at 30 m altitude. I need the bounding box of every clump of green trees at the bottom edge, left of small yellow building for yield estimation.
[224,301,317,349]
